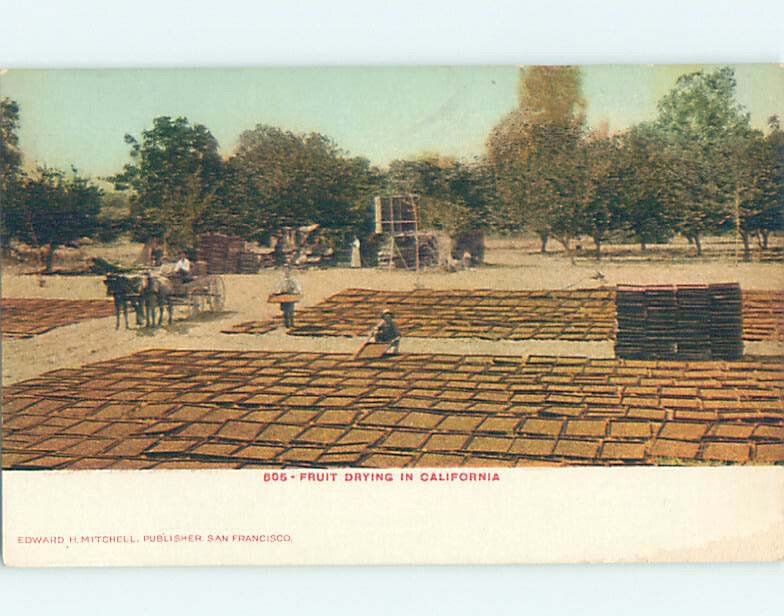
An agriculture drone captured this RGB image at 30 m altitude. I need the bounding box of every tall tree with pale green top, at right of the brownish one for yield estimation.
[655,67,751,256]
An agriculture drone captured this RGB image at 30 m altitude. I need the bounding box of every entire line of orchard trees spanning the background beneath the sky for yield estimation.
[0,66,784,267]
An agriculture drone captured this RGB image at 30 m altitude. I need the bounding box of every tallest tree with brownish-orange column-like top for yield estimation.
[487,66,587,252]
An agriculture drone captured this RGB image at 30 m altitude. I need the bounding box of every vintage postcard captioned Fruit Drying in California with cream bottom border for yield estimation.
[0,64,784,566]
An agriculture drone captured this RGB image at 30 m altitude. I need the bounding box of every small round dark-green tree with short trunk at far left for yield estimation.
[13,167,102,272]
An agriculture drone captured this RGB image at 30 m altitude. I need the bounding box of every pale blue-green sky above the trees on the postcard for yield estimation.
[0,64,784,178]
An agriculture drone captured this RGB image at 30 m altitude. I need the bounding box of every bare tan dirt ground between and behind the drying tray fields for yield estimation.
[2,240,784,384]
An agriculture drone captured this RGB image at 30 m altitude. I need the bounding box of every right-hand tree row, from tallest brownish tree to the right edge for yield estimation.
[488,67,784,259]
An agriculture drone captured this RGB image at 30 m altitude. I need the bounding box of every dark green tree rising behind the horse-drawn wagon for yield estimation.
[112,116,223,247]
